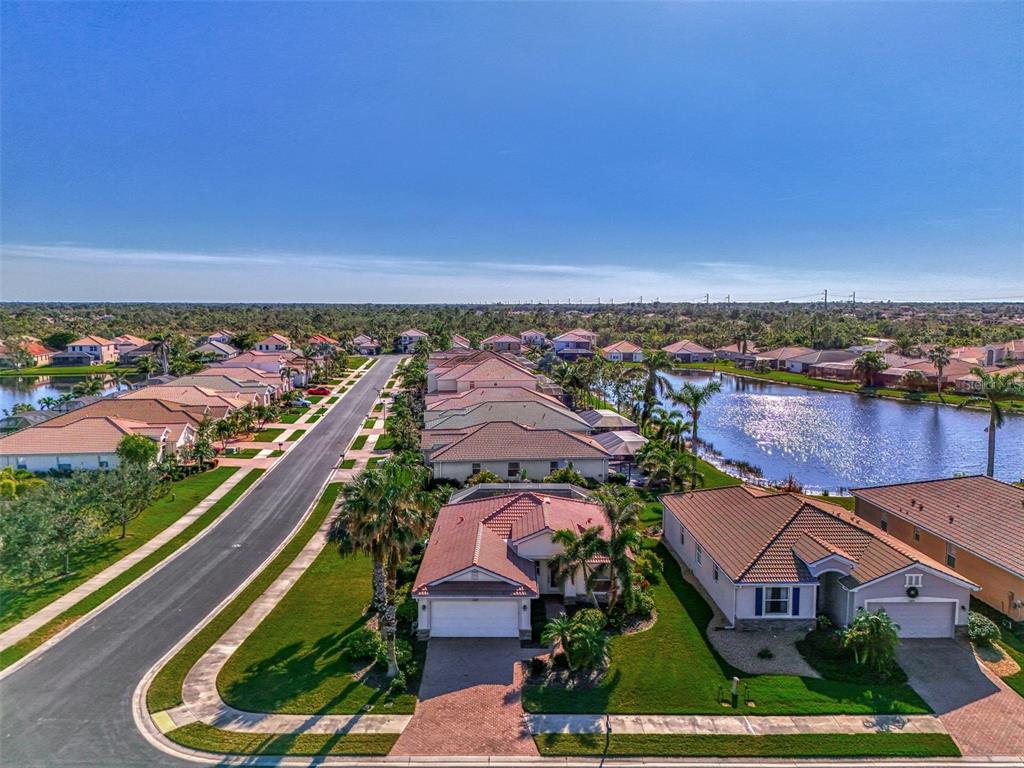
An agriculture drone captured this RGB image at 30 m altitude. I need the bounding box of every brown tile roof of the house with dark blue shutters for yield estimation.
[662,485,970,587]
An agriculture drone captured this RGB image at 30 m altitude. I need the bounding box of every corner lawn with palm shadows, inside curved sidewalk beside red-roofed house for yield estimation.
[217,547,416,715]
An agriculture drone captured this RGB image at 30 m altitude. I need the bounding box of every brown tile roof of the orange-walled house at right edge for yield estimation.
[850,475,1024,577]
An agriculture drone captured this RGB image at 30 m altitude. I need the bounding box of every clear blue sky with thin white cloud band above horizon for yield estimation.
[0,2,1024,302]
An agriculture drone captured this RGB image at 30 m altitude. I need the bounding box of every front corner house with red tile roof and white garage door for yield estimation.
[413,492,608,639]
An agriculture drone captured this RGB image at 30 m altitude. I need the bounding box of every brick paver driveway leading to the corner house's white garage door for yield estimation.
[391,638,537,756]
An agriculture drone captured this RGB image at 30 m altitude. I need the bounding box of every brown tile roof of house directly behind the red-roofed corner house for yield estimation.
[424,421,608,462]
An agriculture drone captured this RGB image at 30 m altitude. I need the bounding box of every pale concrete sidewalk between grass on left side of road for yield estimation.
[0,467,250,650]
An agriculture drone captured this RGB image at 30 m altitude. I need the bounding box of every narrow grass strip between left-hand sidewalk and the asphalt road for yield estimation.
[0,467,264,669]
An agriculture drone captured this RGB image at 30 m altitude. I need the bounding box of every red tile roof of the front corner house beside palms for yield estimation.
[413,493,607,597]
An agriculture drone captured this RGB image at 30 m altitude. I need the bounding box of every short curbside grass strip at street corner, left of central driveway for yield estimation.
[167,723,398,756]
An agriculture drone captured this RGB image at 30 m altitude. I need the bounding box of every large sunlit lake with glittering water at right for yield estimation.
[663,372,1024,492]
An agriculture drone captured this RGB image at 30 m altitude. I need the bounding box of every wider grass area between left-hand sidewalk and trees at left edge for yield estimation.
[0,467,238,630]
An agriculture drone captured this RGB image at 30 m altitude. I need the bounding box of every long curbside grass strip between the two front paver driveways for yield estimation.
[534,733,961,758]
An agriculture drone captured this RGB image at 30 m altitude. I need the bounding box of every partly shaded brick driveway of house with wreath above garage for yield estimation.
[896,640,1024,757]
